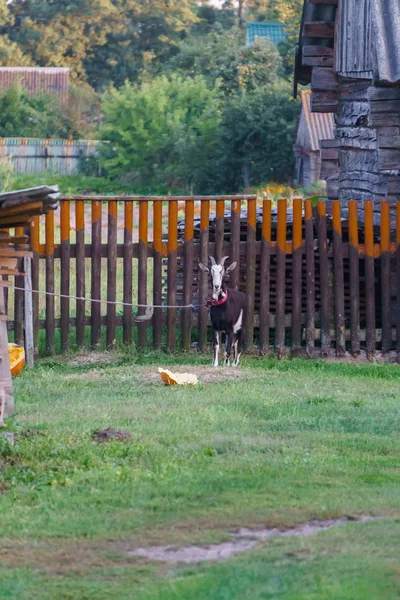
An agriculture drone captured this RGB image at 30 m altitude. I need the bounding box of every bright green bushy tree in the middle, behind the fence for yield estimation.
[102,75,220,190]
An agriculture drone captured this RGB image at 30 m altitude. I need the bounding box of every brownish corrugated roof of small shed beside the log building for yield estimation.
[297,90,335,152]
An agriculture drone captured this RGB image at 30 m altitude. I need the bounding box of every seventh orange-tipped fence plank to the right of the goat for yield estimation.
[332,200,346,357]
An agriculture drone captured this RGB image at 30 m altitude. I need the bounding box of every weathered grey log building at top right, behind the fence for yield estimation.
[294,0,400,203]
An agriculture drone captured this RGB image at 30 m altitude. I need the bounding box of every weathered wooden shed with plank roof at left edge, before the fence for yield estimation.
[0,186,58,425]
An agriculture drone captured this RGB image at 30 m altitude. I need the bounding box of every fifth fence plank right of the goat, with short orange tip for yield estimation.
[304,200,315,358]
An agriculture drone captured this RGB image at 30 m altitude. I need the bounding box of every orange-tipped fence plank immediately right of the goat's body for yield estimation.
[246,200,257,348]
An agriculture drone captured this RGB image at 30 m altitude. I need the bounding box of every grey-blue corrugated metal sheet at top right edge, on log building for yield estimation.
[372,0,400,83]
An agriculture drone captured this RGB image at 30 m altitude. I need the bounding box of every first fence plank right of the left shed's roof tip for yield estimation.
[60,201,71,352]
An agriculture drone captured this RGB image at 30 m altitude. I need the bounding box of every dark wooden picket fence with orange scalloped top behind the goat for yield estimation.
[9,195,400,357]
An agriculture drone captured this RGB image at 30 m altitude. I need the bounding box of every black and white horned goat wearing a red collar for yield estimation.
[199,256,247,367]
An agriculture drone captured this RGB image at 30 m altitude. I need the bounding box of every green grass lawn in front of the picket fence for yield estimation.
[0,351,400,600]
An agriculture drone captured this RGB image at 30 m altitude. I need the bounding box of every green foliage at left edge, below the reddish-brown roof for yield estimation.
[0,83,71,138]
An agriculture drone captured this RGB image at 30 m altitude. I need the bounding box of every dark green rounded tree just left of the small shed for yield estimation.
[215,81,299,192]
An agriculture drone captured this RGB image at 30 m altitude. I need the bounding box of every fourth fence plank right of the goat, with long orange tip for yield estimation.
[292,198,303,356]
